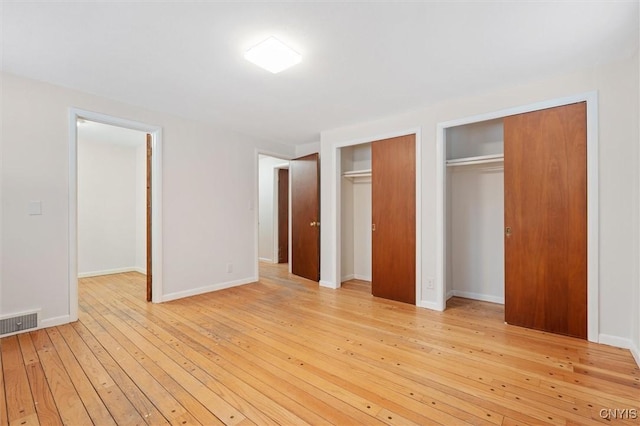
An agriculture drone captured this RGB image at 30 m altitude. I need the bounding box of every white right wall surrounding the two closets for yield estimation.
[321,52,640,346]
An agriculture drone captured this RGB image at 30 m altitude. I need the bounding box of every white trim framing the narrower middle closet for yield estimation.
[330,126,424,306]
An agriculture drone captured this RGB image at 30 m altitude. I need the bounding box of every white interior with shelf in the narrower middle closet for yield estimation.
[340,143,372,282]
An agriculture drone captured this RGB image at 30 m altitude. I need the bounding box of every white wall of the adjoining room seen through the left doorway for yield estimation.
[78,136,145,276]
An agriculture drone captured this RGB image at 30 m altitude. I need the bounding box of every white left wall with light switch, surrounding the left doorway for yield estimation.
[0,73,294,326]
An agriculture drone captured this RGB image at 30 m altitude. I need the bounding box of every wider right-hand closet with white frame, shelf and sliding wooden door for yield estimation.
[434,92,599,342]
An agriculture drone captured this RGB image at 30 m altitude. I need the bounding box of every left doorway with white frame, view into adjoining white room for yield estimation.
[69,109,162,320]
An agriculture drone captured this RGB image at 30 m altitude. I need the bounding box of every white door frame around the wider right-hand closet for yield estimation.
[436,91,600,342]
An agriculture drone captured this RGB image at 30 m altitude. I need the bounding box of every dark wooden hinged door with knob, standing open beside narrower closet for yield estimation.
[289,154,320,281]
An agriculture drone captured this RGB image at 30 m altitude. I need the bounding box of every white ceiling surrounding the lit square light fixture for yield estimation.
[0,0,639,144]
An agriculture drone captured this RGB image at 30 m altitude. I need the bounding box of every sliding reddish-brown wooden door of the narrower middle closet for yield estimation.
[371,135,416,304]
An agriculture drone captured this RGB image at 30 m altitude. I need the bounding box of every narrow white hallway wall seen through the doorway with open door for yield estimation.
[258,155,288,263]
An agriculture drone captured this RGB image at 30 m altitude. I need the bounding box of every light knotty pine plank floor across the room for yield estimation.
[0,265,640,426]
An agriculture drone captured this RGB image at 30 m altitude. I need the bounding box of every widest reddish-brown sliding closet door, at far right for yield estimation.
[504,102,587,339]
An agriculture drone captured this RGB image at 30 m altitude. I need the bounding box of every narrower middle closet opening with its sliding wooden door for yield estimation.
[338,133,420,305]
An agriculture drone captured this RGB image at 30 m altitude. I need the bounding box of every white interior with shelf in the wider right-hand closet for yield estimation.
[445,119,505,304]
